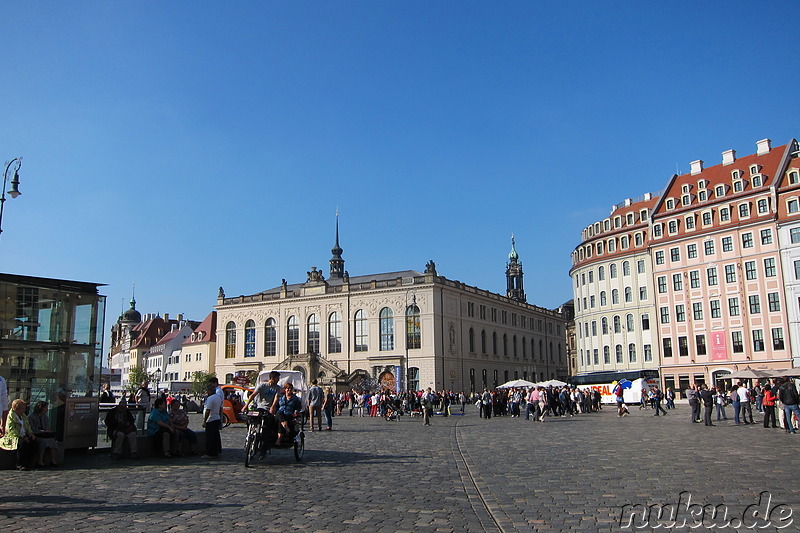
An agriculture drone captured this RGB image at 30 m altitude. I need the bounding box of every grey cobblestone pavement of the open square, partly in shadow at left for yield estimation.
[0,406,800,532]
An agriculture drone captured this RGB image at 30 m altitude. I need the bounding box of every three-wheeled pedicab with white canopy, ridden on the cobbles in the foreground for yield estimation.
[244,370,308,468]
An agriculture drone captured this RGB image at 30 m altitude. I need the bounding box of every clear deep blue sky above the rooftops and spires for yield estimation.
[0,1,800,344]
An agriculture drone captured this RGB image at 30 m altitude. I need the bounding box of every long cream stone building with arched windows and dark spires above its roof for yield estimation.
[216,234,567,392]
